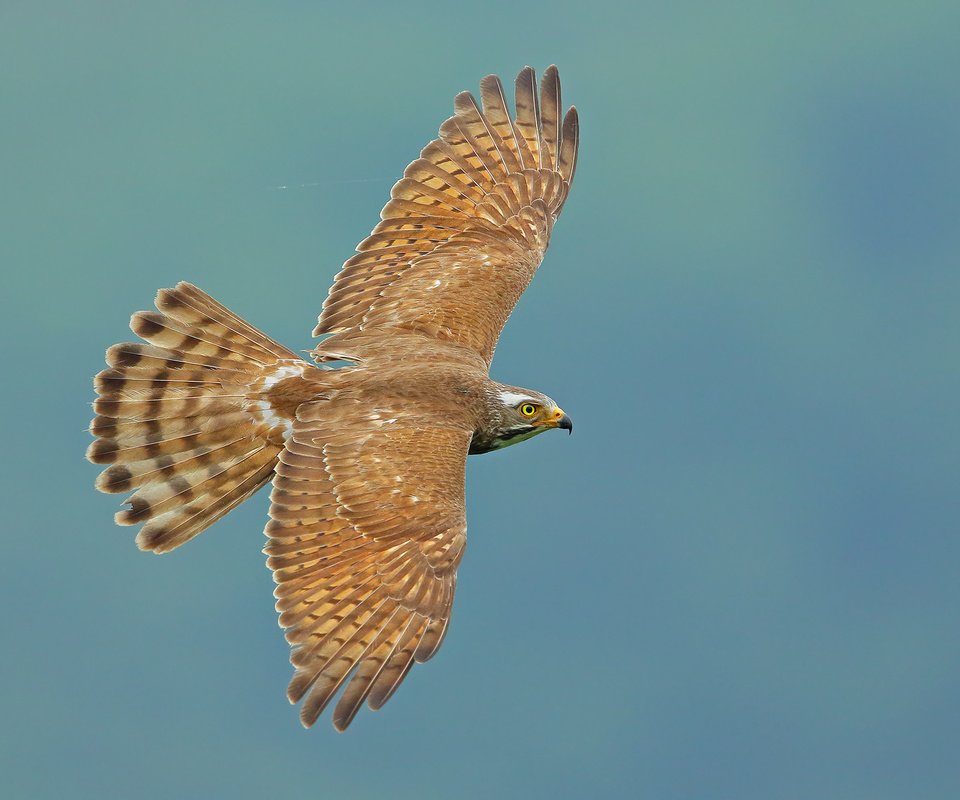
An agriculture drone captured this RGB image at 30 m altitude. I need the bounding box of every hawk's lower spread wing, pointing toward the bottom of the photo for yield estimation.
[264,399,471,730]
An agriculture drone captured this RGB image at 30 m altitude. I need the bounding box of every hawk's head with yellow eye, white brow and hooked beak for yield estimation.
[470,384,573,453]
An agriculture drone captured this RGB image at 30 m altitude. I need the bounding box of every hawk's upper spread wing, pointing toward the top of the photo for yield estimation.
[314,66,579,365]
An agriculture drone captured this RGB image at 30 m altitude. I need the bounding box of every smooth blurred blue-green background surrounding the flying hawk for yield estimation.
[0,0,960,800]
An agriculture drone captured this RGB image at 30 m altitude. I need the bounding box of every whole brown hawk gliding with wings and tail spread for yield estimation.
[87,66,579,730]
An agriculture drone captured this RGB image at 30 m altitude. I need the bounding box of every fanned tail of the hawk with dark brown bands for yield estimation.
[87,283,313,553]
